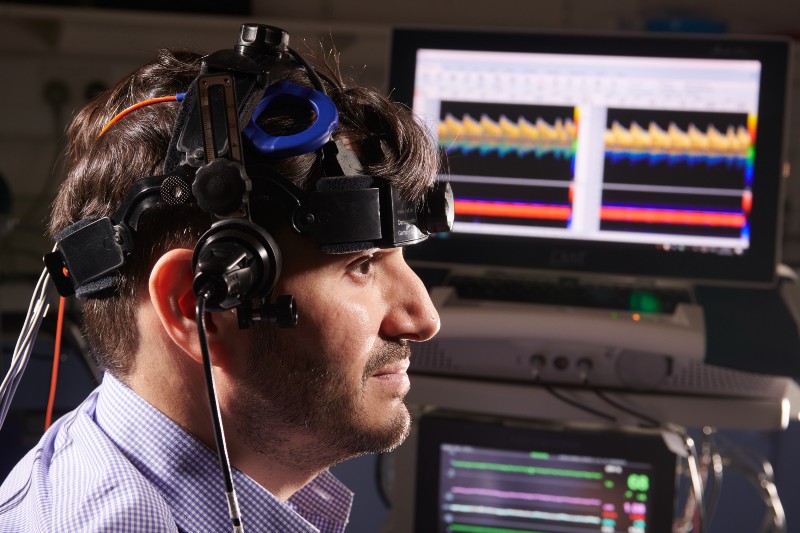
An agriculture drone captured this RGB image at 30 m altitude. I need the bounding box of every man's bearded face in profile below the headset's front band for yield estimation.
[228,236,439,464]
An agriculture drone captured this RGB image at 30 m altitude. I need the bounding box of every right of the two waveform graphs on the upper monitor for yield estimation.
[599,109,756,241]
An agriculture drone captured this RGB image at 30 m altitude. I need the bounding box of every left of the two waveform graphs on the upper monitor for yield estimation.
[437,102,578,228]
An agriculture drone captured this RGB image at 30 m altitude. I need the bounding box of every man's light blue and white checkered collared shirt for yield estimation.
[0,374,353,533]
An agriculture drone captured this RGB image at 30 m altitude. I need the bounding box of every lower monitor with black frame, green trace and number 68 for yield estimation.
[414,415,677,533]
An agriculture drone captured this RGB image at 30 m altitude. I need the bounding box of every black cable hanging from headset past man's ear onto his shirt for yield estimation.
[195,291,244,533]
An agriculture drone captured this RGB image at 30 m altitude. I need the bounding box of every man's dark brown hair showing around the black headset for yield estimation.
[49,46,439,377]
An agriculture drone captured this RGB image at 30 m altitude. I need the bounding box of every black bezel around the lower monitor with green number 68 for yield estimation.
[414,412,679,533]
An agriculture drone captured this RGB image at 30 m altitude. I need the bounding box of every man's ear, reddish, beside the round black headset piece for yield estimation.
[149,248,235,362]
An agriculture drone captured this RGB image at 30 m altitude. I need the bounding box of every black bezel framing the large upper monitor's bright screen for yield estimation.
[389,28,791,286]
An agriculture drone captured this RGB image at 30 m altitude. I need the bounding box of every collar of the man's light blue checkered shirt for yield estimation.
[95,373,353,532]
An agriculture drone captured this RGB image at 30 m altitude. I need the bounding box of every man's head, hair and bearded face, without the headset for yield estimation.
[50,26,439,464]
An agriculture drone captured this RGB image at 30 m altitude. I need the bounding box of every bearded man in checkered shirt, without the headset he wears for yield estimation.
[0,22,446,532]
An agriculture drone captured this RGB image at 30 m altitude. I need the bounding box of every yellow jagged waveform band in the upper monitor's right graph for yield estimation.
[605,120,751,157]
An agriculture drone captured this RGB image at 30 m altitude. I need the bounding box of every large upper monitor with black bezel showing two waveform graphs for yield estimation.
[390,29,789,283]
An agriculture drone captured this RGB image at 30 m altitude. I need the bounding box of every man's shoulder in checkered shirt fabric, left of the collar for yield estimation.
[0,394,176,532]
